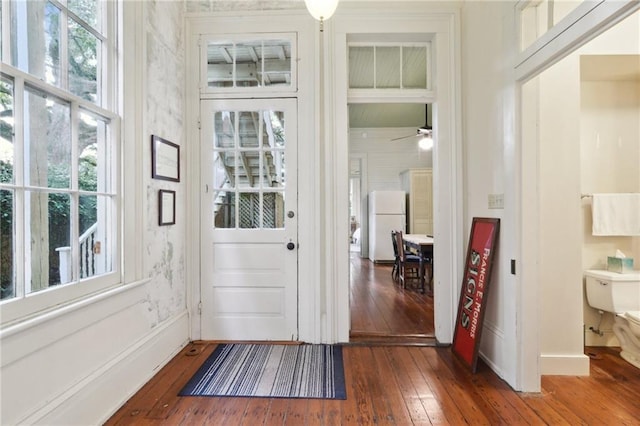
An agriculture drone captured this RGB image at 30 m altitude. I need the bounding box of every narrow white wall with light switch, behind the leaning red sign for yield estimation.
[461,2,519,382]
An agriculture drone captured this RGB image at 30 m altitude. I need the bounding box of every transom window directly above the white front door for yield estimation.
[201,34,296,93]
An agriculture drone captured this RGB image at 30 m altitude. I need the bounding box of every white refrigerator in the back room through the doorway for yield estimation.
[369,191,407,262]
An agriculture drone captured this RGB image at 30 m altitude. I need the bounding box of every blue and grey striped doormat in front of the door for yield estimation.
[179,344,346,399]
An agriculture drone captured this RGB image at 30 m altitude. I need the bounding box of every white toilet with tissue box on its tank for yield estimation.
[584,270,640,368]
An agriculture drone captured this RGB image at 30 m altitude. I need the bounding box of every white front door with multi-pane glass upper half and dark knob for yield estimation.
[200,99,298,340]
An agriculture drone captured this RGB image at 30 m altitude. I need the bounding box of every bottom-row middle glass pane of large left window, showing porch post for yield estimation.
[25,192,72,293]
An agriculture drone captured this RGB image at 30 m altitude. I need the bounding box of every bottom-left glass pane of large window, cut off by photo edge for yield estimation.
[0,189,15,299]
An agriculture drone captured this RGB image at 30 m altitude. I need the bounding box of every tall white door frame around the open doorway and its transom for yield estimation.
[323,3,463,343]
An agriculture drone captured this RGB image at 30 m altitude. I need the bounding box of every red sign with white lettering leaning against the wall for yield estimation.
[452,217,500,373]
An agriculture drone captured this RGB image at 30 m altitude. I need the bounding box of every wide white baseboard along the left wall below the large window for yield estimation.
[20,311,189,425]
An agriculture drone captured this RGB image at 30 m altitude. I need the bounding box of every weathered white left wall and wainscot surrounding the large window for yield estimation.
[0,1,189,425]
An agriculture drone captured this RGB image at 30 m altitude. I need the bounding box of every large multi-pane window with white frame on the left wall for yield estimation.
[0,0,120,322]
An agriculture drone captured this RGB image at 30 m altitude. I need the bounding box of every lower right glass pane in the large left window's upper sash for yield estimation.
[69,19,100,103]
